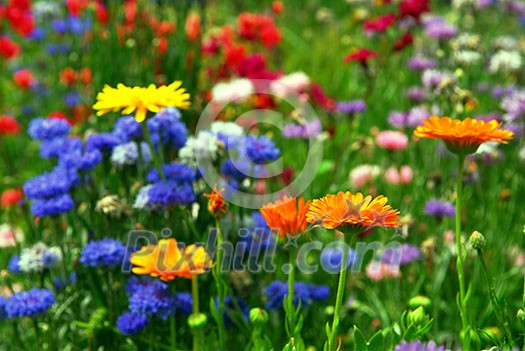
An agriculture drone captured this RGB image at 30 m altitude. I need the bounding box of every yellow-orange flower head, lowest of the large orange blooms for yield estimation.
[130,238,212,281]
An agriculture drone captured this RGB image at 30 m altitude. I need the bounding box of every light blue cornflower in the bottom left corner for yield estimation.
[5,288,55,318]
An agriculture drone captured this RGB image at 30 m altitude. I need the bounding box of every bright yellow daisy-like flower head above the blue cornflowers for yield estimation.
[93,81,191,122]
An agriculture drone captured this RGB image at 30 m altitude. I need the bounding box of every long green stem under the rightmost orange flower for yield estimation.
[456,155,471,351]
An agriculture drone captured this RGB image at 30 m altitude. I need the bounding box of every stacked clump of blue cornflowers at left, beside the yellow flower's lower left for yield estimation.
[24,118,102,217]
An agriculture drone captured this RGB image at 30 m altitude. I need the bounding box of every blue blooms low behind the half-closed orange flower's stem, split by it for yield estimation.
[265,280,330,310]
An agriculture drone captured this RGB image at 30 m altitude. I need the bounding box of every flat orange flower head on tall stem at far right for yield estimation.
[414,116,514,154]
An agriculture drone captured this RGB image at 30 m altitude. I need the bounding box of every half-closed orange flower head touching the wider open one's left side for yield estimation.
[260,196,311,238]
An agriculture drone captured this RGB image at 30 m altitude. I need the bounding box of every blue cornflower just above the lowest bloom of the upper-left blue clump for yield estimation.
[24,167,72,199]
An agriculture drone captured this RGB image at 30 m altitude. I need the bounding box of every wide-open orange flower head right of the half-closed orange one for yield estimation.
[306,191,399,231]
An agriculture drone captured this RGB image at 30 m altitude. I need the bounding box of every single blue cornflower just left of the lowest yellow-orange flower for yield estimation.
[80,238,126,267]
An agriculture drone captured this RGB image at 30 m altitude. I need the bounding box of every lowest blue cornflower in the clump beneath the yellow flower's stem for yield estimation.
[148,180,195,206]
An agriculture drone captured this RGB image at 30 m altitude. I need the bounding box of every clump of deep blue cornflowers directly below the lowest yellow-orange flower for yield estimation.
[117,277,193,335]
